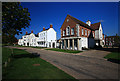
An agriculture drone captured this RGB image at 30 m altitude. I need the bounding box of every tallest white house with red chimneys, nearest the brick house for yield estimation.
[37,24,57,48]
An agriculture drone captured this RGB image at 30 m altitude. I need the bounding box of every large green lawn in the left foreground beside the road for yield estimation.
[2,47,75,80]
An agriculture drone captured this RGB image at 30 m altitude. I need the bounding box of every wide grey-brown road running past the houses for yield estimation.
[6,47,119,79]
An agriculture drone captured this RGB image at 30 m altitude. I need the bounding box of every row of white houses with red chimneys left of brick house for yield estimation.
[18,25,57,48]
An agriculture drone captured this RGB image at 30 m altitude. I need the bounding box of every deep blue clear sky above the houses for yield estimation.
[16,2,118,39]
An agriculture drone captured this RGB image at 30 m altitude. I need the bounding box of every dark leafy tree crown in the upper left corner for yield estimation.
[2,2,31,43]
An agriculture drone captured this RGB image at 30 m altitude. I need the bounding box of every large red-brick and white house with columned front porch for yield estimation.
[60,15,104,50]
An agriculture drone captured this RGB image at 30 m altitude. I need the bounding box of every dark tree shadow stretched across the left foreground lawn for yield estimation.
[13,53,40,58]
